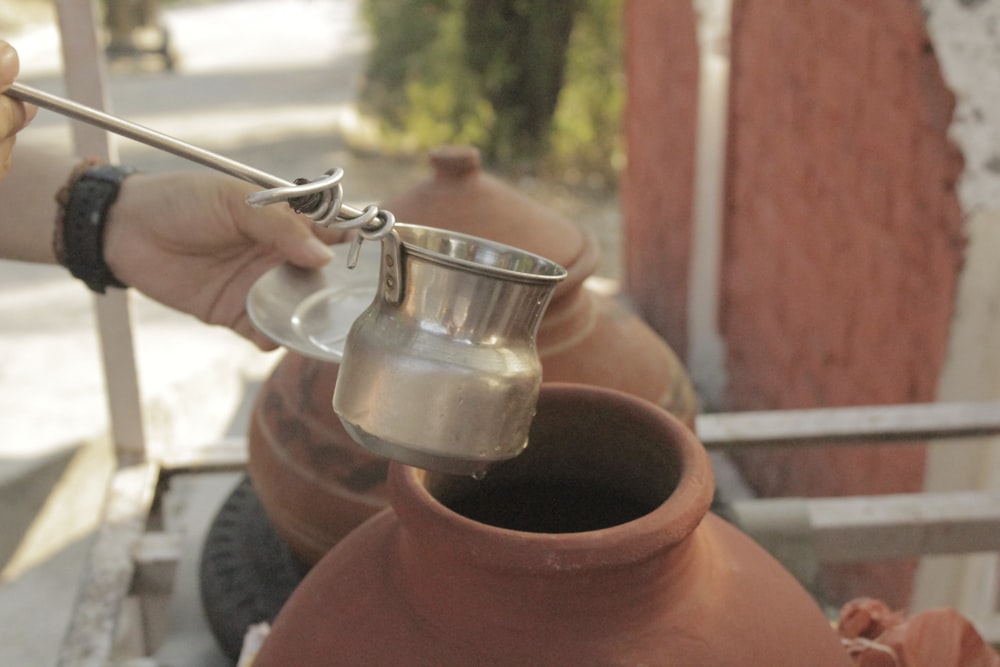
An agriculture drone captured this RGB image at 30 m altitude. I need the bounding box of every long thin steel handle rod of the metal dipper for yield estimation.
[4,82,363,217]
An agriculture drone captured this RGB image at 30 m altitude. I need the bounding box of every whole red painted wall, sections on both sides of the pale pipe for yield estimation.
[623,0,963,605]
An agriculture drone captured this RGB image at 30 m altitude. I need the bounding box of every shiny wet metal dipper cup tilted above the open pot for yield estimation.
[333,223,566,474]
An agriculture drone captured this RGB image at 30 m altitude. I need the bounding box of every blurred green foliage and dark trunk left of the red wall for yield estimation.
[361,0,625,183]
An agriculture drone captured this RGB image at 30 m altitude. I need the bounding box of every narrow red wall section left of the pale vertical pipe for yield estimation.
[621,0,698,359]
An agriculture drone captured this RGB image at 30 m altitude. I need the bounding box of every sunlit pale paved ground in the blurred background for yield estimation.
[0,0,617,666]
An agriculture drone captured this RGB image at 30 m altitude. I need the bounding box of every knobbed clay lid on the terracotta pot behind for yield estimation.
[382,145,599,291]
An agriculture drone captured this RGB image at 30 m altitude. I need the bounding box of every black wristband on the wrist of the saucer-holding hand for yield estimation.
[53,160,135,294]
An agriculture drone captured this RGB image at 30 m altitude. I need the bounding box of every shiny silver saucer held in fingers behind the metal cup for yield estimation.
[247,242,380,362]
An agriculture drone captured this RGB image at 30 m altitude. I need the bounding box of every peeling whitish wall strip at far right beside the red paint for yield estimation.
[913,0,1000,630]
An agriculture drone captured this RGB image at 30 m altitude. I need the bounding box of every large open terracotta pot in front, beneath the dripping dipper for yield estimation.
[254,384,851,667]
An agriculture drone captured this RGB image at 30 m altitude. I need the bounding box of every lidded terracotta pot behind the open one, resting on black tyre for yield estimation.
[249,146,697,563]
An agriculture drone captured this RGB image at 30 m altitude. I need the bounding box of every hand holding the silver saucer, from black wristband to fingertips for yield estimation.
[104,171,344,350]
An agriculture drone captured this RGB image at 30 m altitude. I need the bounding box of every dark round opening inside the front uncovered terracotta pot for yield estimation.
[423,394,683,533]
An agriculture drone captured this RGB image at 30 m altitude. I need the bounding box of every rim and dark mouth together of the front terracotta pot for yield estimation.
[389,384,714,577]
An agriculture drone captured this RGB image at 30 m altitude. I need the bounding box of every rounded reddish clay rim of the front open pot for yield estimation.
[389,382,715,570]
